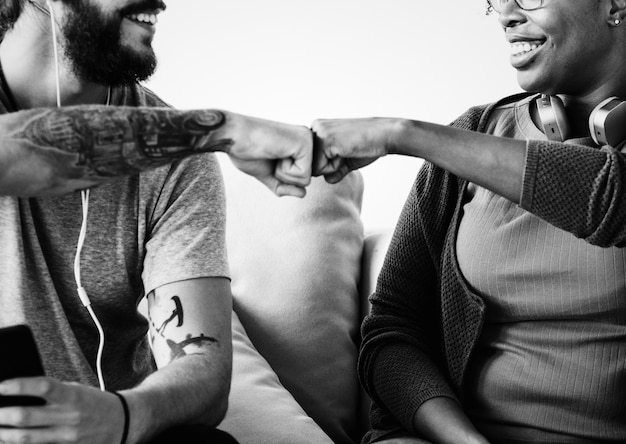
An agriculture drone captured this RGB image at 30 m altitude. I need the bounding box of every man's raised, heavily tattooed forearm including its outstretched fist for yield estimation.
[0,106,312,197]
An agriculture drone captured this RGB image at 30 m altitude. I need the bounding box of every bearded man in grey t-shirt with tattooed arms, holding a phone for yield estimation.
[0,0,312,444]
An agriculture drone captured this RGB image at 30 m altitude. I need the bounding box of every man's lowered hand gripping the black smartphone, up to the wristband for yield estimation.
[0,377,124,444]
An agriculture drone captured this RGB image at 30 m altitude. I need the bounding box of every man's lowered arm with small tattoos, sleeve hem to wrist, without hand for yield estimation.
[123,278,232,443]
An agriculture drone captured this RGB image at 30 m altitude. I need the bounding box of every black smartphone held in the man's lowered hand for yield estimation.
[0,325,46,407]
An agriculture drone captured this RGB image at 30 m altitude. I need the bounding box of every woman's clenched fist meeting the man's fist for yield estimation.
[311,118,394,183]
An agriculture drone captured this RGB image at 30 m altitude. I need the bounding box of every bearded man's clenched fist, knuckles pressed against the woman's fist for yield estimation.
[226,115,313,197]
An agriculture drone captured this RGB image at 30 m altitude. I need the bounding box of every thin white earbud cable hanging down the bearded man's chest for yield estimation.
[46,0,105,391]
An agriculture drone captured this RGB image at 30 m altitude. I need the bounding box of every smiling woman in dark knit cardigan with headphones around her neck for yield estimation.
[313,0,626,444]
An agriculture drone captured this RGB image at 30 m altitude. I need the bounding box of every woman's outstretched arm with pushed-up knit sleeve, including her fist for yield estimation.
[313,114,626,247]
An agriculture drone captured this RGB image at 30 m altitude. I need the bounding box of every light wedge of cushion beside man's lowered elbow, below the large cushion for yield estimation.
[219,312,332,444]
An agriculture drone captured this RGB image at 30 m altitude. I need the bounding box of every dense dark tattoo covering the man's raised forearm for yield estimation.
[14,106,234,178]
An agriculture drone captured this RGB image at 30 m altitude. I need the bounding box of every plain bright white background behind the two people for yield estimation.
[148,0,519,229]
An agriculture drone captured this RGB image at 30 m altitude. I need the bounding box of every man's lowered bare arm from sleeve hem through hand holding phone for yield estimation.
[0,278,232,444]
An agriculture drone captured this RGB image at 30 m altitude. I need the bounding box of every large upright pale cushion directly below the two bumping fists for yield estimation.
[221,158,363,443]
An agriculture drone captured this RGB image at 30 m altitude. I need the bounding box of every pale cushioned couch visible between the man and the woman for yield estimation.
[214,158,391,444]
